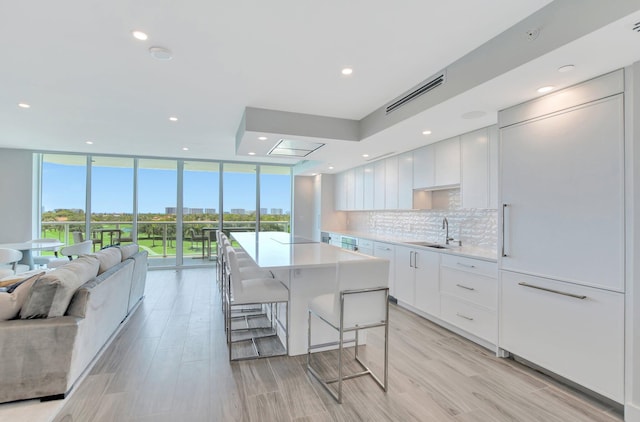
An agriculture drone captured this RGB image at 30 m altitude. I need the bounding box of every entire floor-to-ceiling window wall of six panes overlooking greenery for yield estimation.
[40,154,292,268]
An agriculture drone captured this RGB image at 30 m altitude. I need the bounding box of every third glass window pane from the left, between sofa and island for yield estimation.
[138,159,177,266]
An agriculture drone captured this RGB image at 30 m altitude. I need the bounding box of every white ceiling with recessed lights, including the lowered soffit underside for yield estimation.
[0,0,640,171]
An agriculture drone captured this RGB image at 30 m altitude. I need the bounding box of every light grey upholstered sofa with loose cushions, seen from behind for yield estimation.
[0,245,147,403]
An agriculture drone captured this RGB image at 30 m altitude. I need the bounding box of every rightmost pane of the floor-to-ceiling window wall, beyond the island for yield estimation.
[259,165,291,232]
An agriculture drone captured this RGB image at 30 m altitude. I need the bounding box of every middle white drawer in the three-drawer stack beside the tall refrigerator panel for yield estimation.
[440,267,498,309]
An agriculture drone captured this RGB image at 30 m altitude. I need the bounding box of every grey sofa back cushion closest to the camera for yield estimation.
[20,255,100,319]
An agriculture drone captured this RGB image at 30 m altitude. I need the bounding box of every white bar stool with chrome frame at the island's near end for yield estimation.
[307,259,389,403]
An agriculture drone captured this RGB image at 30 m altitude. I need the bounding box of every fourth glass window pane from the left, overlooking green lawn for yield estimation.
[182,161,220,265]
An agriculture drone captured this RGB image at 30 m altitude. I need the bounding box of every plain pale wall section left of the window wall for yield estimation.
[0,149,33,243]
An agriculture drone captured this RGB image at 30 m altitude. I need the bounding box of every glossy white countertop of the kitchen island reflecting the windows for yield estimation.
[231,232,378,269]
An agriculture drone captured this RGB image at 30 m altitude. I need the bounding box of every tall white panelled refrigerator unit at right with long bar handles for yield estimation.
[499,71,625,403]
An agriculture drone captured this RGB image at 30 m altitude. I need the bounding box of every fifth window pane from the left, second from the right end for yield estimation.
[222,163,256,235]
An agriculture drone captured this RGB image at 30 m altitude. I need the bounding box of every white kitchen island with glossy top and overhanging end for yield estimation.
[231,232,388,356]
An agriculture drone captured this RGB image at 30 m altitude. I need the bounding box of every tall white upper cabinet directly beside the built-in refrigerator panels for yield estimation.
[460,126,498,209]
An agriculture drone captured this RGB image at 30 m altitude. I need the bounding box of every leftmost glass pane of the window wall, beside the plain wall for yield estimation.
[42,154,87,244]
